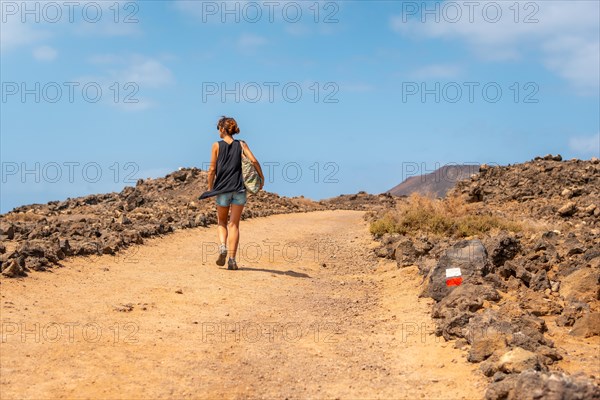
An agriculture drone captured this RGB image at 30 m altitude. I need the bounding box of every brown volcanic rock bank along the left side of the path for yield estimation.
[0,168,393,277]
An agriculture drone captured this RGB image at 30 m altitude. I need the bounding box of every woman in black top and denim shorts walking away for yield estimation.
[200,117,265,269]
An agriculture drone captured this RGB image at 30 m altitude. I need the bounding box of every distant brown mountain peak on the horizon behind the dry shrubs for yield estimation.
[386,165,479,197]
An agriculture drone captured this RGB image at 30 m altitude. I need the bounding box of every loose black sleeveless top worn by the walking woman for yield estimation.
[200,140,246,199]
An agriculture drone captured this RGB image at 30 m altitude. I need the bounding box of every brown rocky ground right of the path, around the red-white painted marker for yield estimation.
[377,156,600,400]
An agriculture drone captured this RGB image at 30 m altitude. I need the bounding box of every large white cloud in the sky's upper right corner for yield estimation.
[390,0,600,93]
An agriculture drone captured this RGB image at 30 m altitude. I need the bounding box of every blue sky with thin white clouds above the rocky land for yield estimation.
[0,0,600,212]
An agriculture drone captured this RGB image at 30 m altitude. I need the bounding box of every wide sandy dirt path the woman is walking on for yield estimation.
[0,211,485,399]
